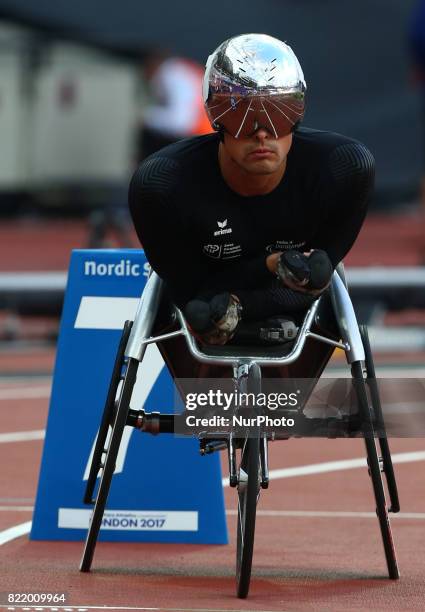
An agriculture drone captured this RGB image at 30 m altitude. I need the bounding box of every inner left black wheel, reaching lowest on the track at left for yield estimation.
[80,359,139,572]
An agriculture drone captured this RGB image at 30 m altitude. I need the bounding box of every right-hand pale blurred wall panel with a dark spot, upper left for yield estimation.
[31,44,136,185]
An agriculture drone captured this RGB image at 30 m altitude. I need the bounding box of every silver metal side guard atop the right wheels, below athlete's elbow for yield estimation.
[331,272,365,364]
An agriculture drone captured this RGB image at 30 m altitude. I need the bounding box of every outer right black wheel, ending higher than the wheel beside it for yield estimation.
[360,325,400,513]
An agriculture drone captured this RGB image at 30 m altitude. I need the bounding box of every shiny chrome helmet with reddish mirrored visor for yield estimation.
[203,34,306,138]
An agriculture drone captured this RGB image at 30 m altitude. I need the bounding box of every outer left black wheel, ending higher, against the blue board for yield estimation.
[83,321,132,504]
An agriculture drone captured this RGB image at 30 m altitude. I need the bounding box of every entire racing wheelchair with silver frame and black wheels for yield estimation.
[80,265,400,598]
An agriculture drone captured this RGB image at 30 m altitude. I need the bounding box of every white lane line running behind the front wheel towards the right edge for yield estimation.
[222,451,425,487]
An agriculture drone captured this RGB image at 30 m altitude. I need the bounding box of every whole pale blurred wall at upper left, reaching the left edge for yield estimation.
[0,23,137,190]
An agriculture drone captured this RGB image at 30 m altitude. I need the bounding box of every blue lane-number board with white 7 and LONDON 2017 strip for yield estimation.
[30,250,227,544]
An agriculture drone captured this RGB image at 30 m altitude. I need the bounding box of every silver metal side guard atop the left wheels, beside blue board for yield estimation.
[125,272,164,361]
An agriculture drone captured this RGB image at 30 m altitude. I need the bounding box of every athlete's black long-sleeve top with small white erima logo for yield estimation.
[129,128,374,318]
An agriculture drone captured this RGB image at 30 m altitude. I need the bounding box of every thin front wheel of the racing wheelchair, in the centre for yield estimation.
[236,364,261,598]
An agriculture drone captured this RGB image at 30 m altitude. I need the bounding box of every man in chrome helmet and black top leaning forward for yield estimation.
[129,34,374,344]
